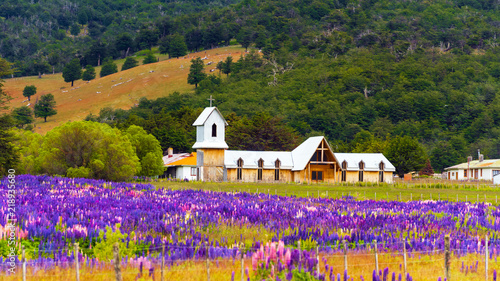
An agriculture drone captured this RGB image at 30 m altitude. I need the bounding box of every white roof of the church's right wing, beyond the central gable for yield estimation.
[334,153,396,172]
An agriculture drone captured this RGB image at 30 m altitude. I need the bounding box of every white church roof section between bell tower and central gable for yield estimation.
[224,150,293,170]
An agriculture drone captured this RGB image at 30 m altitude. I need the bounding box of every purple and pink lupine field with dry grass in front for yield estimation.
[0,175,500,281]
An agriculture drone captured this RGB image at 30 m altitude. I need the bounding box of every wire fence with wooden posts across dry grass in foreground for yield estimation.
[4,235,500,281]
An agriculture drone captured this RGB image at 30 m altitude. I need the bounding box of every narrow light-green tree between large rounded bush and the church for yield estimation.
[125,125,163,177]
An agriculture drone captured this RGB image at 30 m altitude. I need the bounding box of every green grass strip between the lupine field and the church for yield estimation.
[152,179,500,205]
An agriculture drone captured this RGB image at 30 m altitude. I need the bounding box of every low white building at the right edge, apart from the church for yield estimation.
[445,155,500,181]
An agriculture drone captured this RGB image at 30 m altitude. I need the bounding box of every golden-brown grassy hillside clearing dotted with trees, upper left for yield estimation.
[5,46,244,134]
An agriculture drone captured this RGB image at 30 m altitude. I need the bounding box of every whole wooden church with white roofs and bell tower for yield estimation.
[193,107,395,183]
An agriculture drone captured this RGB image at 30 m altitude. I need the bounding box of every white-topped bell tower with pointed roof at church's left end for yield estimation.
[193,107,228,182]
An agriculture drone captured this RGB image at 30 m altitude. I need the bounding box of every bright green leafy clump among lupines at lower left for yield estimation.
[94,223,136,261]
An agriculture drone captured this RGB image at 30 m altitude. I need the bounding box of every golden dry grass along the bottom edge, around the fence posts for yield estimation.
[0,250,500,281]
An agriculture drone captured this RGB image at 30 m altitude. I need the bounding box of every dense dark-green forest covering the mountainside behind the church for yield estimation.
[0,0,500,171]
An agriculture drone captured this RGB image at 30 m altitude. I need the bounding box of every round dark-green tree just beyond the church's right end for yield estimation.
[385,136,427,178]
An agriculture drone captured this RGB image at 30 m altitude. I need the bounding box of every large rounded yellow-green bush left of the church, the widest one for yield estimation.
[37,121,140,181]
